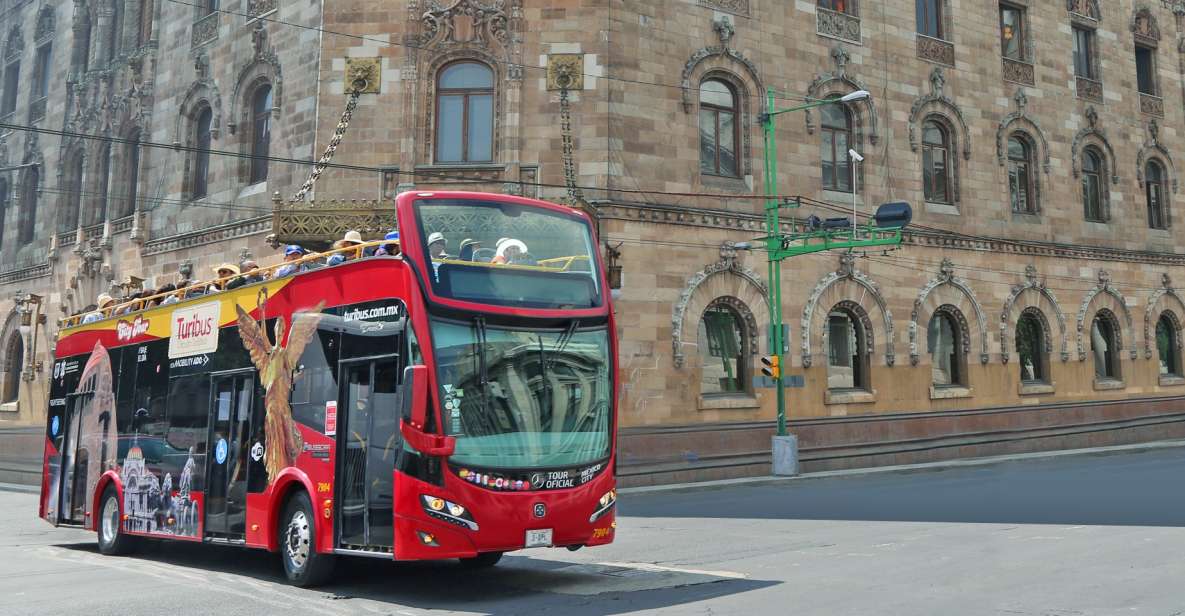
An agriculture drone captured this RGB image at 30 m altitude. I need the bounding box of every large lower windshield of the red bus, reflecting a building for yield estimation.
[433,320,613,469]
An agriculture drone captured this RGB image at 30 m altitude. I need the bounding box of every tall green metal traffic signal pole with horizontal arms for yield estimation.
[761,88,901,436]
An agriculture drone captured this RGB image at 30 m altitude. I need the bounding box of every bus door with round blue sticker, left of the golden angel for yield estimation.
[205,370,257,539]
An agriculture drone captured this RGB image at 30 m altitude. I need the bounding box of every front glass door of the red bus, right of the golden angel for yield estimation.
[337,355,403,551]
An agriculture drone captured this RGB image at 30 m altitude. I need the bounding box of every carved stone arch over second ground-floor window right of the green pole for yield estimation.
[909,258,991,366]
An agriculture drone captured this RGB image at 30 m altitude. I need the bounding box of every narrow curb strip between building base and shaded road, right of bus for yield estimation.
[617,439,1185,494]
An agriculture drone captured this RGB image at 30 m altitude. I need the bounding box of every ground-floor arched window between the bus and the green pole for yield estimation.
[699,302,749,394]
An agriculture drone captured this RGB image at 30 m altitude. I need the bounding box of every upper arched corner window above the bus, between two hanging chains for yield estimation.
[436,62,494,162]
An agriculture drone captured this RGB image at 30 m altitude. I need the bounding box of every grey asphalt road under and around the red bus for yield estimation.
[0,448,1185,616]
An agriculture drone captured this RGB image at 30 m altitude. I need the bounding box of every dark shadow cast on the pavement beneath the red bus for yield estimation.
[57,541,779,616]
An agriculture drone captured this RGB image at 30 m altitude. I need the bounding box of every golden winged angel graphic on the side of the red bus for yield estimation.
[235,290,325,485]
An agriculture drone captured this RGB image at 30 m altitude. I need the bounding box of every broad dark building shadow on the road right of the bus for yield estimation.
[619,448,1185,526]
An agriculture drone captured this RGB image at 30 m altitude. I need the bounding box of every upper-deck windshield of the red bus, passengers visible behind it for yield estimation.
[416,199,601,309]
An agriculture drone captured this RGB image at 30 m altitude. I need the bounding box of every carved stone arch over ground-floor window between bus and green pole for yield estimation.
[671,250,769,368]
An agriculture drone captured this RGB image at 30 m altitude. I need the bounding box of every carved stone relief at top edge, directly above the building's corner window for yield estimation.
[421,0,511,47]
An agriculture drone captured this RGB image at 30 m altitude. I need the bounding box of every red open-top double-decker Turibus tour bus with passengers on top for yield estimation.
[40,192,617,585]
